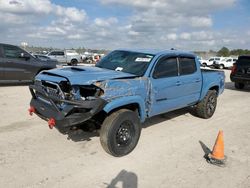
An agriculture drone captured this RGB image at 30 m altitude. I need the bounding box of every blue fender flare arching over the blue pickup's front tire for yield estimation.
[103,96,146,122]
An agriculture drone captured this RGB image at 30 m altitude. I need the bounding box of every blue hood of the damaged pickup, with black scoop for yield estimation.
[36,66,135,85]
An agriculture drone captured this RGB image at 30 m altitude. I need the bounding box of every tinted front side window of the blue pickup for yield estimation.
[153,57,178,79]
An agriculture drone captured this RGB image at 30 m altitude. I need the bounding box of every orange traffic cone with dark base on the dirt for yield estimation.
[208,131,226,166]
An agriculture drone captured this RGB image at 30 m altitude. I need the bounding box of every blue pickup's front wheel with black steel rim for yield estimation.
[100,109,141,157]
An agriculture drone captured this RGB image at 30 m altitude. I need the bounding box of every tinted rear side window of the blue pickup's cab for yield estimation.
[178,57,197,75]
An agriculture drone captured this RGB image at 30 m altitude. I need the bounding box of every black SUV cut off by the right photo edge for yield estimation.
[230,55,250,89]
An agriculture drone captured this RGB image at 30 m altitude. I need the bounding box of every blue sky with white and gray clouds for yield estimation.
[0,0,250,51]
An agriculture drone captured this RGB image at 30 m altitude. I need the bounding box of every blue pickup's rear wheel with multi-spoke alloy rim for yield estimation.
[195,90,217,119]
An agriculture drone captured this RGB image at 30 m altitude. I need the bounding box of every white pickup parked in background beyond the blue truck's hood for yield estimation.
[48,50,82,65]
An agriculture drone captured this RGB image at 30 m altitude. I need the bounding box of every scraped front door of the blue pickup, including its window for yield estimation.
[148,56,182,116]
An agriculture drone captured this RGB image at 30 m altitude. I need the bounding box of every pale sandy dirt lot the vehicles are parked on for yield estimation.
[0,71,250,188]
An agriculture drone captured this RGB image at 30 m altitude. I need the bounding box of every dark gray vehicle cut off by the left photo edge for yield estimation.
[0,43,56,82]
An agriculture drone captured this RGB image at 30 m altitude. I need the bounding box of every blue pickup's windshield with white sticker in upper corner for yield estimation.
[96,50,154,76]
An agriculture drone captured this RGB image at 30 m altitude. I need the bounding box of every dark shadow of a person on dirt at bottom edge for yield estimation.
[105,170,138,188]
